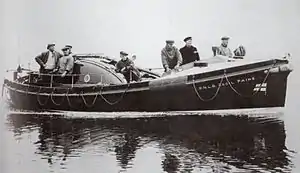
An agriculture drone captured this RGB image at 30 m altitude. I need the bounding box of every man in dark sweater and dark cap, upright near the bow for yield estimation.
[180,37,200,65]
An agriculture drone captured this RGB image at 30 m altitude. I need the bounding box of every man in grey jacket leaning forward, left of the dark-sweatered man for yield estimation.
[161,40,182,72]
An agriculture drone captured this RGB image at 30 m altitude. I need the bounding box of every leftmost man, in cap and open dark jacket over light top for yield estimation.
[35,43,62,73]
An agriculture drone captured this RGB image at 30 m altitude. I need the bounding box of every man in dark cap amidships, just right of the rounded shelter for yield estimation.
[116,51,141,83]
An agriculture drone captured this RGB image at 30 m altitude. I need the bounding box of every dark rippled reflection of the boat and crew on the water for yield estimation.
[8,111,291,172]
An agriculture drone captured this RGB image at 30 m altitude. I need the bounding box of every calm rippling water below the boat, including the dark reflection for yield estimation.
[0,107,295,173]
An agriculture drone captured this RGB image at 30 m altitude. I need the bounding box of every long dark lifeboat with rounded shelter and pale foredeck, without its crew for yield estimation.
[2,54,292,112]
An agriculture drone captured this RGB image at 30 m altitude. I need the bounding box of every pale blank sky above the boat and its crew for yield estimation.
[0,0,300,70]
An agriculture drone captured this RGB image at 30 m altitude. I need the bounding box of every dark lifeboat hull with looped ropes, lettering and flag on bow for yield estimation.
[5,58,290,112]
